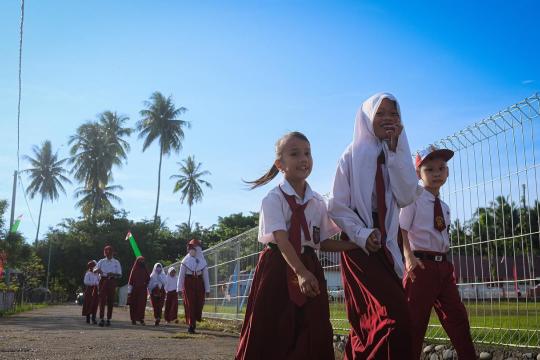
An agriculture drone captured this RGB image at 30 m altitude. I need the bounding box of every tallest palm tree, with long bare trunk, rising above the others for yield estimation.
[137,91,191,225]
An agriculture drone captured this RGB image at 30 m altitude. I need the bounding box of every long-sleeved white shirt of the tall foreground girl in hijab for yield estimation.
[328,147,416,278]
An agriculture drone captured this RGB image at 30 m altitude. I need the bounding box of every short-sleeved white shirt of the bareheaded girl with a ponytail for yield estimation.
[259,179,341,250]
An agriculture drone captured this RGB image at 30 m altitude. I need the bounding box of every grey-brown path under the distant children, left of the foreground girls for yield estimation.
[0,305,238,360]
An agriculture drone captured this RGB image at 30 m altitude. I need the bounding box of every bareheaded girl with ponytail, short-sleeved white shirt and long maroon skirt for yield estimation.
[236,132,357,360]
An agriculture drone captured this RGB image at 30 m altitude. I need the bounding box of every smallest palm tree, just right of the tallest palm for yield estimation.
[171,156,212,229]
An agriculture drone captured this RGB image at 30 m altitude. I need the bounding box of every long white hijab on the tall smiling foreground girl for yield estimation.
[349,93,416,229]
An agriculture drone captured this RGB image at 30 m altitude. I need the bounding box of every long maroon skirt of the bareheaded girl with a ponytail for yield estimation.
[235,248,334,360]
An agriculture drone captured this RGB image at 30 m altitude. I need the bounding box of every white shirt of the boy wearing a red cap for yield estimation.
[399,190,450,253]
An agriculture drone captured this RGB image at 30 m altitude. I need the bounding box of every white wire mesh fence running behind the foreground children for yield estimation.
[169,94,540,347]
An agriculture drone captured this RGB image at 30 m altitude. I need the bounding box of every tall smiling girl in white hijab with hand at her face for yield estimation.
[328,93,421,360]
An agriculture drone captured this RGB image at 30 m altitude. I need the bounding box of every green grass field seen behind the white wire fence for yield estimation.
[198,300,540,347]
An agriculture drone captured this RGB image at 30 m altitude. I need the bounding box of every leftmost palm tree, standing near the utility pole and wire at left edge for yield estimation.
[24,140,71,244]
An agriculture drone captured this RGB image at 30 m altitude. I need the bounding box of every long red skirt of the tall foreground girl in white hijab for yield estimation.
[341,249,412,360]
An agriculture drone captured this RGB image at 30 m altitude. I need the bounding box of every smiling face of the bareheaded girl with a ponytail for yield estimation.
[275,136,313,183]
